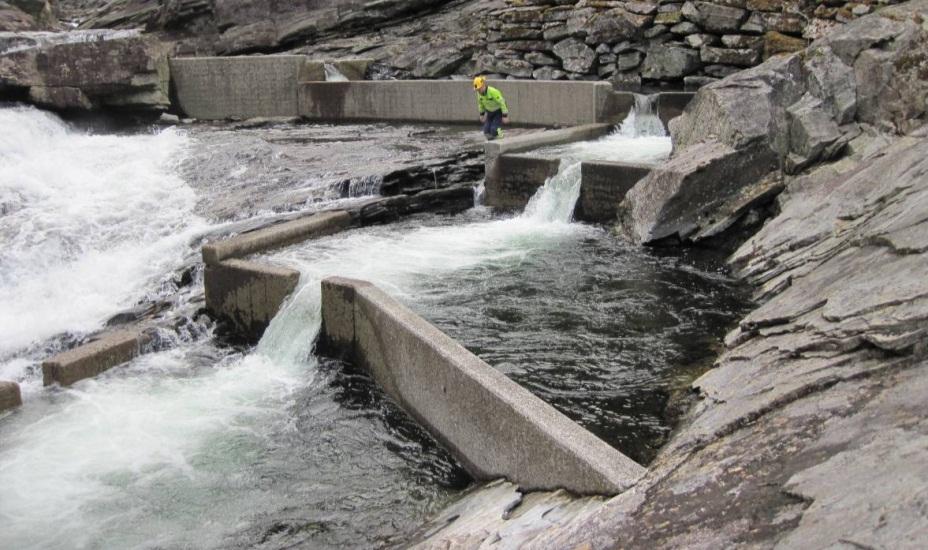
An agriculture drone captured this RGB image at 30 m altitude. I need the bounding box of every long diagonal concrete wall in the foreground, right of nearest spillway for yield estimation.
[322,278,644,494]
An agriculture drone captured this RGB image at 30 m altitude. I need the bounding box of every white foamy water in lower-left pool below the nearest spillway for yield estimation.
[0,349,311,548]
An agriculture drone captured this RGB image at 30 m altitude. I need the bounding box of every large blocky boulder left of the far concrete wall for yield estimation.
[0,31,170,111]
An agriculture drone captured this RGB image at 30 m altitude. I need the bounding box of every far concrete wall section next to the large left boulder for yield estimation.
[170,55,370,120]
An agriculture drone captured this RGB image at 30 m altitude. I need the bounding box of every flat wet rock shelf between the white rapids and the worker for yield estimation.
[180,120,484,220]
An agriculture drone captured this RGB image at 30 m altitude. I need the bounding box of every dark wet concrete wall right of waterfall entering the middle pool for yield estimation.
[574,162,653,223]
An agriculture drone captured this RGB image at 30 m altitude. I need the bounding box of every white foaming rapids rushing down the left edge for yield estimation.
[0,108,209,370]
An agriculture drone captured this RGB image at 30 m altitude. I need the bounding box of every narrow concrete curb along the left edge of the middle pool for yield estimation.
[202,210,352,265]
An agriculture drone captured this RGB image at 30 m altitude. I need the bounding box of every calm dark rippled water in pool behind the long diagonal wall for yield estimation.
[407,218,749,464]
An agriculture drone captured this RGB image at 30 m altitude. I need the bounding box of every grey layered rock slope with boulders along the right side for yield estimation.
[422,0,928,549]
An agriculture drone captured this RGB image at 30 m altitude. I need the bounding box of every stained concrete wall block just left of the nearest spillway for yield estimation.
[203,259,300,341]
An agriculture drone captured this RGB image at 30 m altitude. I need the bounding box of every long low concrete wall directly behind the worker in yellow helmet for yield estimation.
[299,80,634,126]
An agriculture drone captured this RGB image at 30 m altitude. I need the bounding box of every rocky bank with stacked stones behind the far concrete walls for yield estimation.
[0,0,912,115]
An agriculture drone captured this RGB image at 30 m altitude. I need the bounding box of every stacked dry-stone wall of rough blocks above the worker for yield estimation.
[475,0,899,91]
